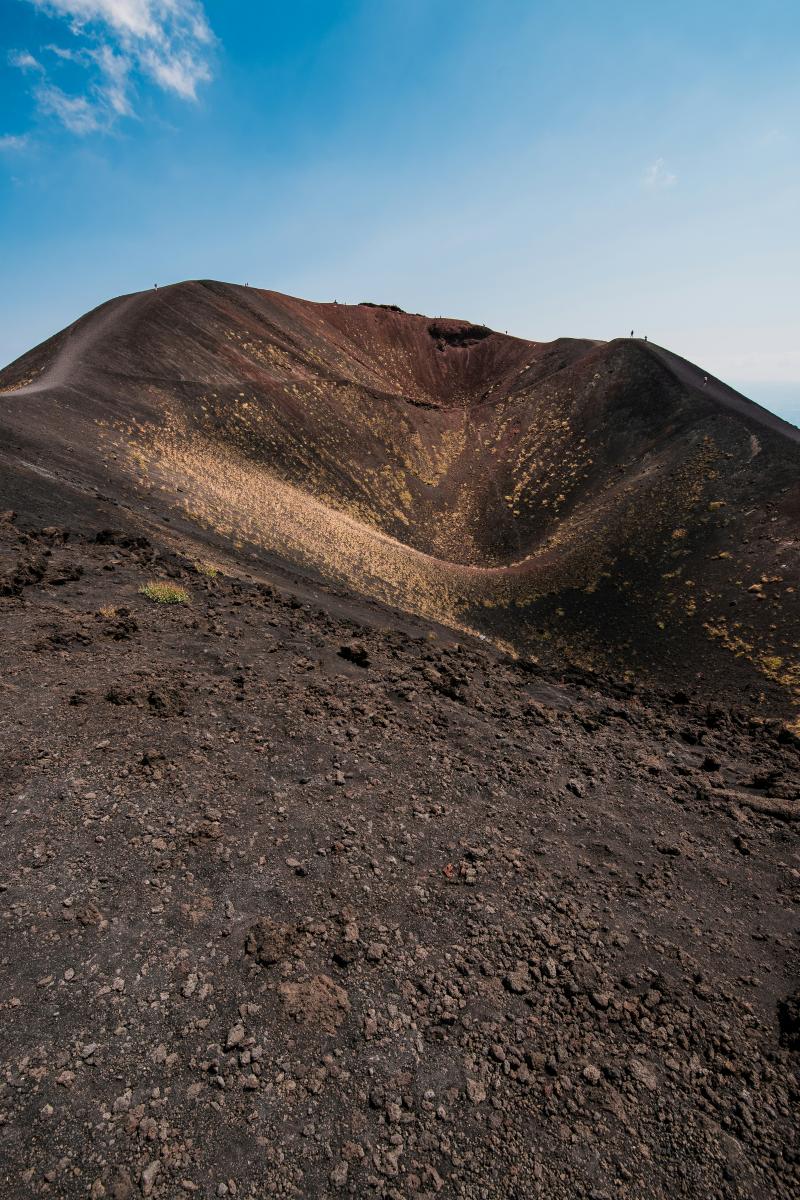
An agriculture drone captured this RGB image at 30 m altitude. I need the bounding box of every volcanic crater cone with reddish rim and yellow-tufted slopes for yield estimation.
[0,282,800,706]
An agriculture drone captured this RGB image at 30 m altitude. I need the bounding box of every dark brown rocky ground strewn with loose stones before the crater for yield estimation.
[0,511,800,1200]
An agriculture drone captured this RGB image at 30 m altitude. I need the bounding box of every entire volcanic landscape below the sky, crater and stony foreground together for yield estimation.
[0,284,800,1200]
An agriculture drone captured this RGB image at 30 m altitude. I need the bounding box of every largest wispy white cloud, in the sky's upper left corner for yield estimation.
[11,0,213,134]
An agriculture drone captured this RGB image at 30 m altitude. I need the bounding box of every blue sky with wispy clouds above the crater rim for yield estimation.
[0,0,800,422]
